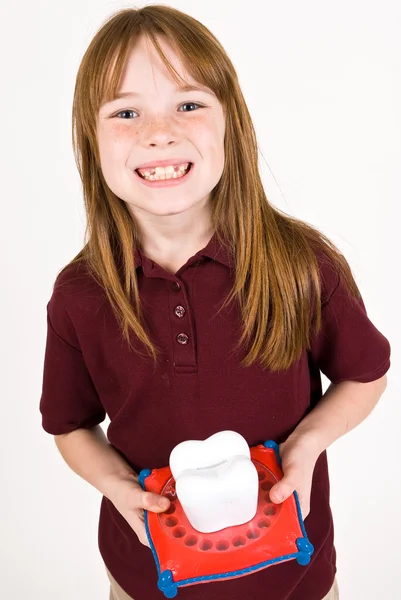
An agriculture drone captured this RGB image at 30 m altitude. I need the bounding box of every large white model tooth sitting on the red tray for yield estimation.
[169,430,259,533]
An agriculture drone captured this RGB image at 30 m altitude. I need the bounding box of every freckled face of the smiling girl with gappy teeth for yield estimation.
[97,36,225,220]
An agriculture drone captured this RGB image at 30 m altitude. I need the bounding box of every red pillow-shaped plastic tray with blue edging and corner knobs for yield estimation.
[139,440,314,598]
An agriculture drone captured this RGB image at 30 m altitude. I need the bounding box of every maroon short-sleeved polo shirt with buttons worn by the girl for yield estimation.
[40,235,390,600]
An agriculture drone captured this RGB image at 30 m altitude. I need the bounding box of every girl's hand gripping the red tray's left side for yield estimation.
[109,474,170,548]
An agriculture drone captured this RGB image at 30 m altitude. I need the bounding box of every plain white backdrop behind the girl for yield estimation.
[0,0,401,600]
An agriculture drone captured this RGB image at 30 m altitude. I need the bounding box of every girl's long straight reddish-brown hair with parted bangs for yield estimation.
[56,5,360,371]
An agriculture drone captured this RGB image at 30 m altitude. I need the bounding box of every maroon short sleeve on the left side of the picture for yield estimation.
[40,294,106,435]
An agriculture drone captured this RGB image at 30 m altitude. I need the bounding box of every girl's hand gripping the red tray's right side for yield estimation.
[270,434,319,519]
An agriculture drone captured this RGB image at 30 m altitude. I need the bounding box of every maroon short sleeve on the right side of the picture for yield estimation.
[310,255,391,384]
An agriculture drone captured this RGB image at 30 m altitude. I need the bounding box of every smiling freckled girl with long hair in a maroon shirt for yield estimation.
[40,6,390,600]
